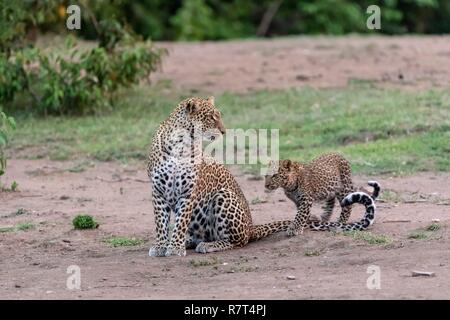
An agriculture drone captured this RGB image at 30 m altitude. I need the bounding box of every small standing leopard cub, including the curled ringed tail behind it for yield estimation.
[265,154,380,236]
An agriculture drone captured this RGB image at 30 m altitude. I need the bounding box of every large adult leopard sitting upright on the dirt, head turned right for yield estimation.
[148,98,290,256]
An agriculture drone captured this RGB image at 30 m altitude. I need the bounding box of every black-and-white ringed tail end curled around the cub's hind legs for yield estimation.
[309,191,379,231]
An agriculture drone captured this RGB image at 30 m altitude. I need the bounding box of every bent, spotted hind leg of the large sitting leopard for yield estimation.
[195,190,250,253]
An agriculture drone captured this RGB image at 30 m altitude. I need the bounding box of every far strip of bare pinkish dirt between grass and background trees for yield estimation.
[153,36,450,93]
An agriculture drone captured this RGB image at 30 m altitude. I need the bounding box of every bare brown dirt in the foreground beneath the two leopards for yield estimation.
[0,160,450,299]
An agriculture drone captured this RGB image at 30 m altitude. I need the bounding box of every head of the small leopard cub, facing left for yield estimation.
[265,160,297,190]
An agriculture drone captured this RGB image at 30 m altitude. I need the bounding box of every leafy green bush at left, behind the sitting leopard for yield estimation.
[0,0,165,115]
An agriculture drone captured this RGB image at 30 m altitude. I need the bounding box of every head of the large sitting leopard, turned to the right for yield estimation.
[181,97,225,140]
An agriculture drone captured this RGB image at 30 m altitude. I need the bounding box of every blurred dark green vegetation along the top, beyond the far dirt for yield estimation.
[7,0,450,40]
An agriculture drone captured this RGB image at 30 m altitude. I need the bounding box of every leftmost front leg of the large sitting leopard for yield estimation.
[148,189,171,257]
